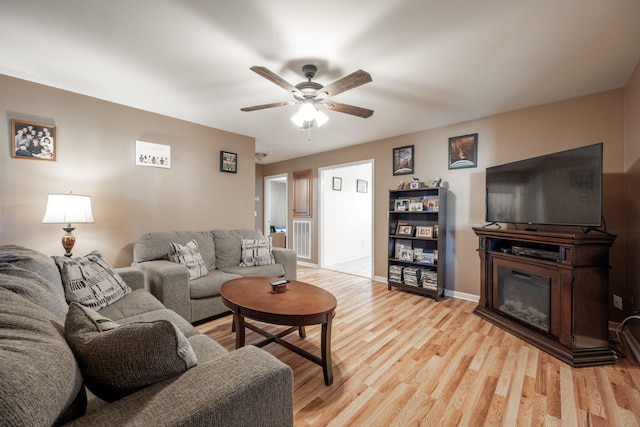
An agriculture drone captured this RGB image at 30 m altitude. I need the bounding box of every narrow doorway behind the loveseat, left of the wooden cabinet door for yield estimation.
[264,173,291,248]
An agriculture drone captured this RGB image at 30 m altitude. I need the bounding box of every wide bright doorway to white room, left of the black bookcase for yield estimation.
[318,160,374,278]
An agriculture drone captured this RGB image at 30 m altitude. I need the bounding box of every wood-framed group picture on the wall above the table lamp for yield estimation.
[11,119,58,161]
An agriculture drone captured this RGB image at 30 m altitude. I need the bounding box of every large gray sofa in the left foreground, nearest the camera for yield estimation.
[0,245,293,426]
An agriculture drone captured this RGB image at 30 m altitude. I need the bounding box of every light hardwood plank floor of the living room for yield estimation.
[198,267,640,427]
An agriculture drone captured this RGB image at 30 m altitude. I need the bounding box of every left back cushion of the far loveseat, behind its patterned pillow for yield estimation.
[133,231,216,271]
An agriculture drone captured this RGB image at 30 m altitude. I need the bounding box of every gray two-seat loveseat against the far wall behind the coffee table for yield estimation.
[132,229,297,323]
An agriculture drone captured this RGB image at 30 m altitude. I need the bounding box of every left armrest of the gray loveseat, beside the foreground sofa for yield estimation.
[130,260,191,322]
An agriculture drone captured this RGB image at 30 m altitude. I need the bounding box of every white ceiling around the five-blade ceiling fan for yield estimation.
[0,0,640,163]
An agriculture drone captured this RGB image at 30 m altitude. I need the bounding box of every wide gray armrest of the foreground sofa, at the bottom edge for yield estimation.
[65,346,293,426]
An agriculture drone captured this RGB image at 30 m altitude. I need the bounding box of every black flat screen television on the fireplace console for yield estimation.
[485,143,602,227]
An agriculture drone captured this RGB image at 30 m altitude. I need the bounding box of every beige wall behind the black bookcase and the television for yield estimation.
[261,90,624,295]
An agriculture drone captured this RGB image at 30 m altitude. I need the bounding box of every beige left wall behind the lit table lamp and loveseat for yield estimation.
[0,75,255,266]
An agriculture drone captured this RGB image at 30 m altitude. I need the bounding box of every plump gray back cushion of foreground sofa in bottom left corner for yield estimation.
[0,288,87,426]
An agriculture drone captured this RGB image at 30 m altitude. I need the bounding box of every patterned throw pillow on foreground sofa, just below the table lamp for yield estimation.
[52,251,131,310]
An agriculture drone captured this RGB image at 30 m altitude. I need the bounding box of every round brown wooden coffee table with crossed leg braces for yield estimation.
[220,277,337,385]
